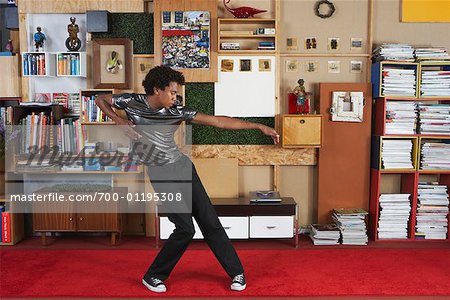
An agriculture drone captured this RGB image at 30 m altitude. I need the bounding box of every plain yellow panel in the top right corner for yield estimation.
[401,0,450,22]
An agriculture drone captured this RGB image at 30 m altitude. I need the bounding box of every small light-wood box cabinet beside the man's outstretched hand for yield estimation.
[281,115,322,148]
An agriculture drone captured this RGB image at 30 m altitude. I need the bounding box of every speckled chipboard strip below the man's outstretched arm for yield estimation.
[192,145,317,166]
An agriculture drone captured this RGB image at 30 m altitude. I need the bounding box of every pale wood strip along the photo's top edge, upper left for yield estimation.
[18,0,144,13]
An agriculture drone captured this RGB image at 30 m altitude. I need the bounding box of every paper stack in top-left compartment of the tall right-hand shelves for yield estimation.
[381,66,416,97]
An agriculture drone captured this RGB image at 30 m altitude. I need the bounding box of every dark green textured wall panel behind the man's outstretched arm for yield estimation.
[186,83,275,145]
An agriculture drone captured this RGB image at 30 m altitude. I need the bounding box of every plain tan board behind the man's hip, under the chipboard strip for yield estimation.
[192,158,239,198]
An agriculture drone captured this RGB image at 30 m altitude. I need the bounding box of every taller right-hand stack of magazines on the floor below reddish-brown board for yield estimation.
[333,209,368,245]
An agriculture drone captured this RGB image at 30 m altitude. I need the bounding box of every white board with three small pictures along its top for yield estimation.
[214,56,276,117]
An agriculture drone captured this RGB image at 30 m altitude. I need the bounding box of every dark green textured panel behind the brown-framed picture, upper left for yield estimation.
[92,13,154,54]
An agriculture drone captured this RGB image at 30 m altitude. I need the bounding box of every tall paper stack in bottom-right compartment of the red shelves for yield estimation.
[415,182,449,239]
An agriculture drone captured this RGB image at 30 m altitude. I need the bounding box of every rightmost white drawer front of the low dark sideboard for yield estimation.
[250,216,294,238]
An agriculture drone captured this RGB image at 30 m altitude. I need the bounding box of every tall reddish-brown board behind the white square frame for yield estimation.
[317,83,372,223]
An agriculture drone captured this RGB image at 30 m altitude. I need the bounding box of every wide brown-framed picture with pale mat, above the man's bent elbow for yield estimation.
[92,39,133,89]
